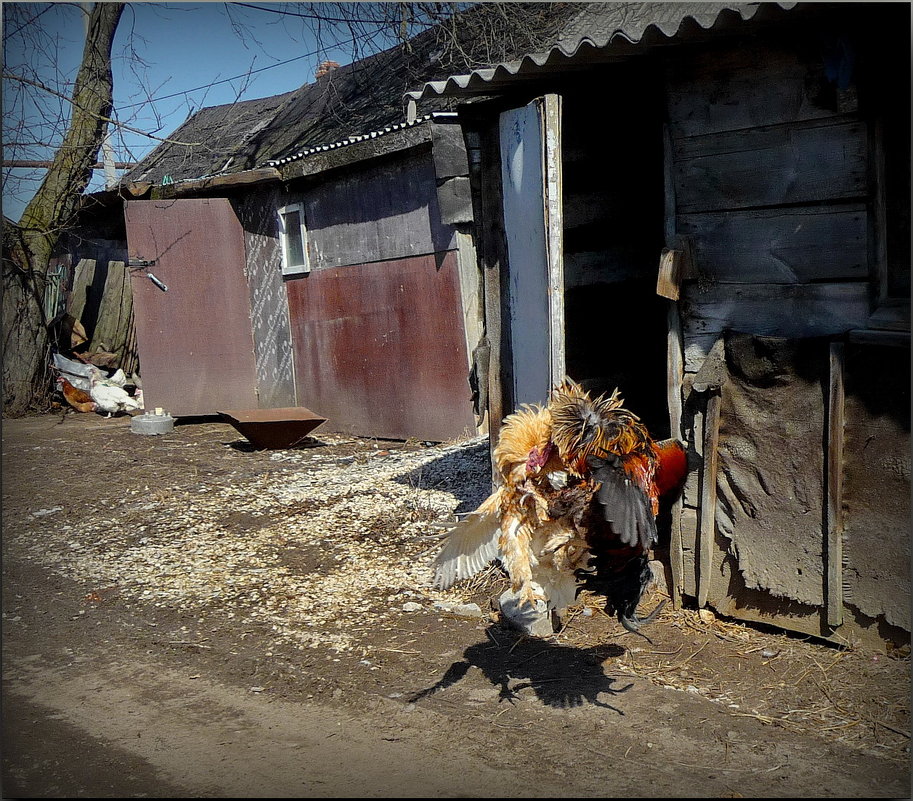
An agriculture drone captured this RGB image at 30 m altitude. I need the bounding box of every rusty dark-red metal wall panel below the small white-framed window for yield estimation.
[287,251,475,441]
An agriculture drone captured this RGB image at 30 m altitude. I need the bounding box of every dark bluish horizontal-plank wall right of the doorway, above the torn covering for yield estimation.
[668,42,872,371]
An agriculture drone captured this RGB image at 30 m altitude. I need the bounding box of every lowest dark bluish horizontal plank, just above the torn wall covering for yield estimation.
[682,282,869,342]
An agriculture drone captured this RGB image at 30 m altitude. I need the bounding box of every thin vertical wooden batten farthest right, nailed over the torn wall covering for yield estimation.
[824,342,844,628]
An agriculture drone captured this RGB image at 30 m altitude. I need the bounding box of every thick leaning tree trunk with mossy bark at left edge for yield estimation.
[2,3,124,417]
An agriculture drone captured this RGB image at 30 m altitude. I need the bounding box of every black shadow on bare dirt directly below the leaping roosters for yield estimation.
[409,624,633,715]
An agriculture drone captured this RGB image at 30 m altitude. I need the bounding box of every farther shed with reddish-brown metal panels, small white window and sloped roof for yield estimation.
[79,25,512,441]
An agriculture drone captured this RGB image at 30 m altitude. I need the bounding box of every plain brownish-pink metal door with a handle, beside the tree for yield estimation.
[124,198,258,417]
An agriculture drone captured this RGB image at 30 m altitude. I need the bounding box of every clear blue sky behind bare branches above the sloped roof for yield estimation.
[3,0,402,220]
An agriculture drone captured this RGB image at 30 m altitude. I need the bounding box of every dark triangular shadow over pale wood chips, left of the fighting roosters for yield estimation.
[393,439,491,515]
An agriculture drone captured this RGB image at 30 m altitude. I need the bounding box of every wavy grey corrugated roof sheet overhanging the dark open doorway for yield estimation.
[407,2,799,100]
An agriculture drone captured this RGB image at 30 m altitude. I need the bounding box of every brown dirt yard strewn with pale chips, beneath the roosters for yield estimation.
[2,413,911,798]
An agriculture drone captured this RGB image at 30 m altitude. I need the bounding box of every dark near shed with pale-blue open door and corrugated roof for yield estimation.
[409,2,910,644]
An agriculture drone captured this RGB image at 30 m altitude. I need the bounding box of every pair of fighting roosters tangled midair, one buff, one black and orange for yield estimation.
[435,380,687,632]
